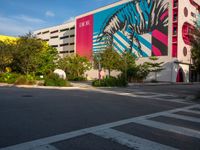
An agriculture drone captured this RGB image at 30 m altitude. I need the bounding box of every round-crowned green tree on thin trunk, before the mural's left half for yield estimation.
[97,47,122,77]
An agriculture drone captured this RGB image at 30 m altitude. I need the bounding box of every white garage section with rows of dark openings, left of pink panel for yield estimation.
[33,22,75,57]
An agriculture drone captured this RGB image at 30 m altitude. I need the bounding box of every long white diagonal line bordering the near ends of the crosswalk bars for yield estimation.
[0,104,199,150]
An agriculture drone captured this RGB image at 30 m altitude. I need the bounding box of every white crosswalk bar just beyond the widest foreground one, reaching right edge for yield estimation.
[134,119,200,139]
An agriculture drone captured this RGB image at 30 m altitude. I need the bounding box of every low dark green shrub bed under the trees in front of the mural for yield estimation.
[92,76,127,87]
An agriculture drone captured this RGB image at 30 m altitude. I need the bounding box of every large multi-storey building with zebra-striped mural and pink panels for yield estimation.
[35,0,200,82]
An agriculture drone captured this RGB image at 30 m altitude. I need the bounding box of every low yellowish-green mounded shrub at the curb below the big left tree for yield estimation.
[15,75,36,85]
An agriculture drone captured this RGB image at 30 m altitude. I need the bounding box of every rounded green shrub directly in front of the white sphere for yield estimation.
[44,73,70,86]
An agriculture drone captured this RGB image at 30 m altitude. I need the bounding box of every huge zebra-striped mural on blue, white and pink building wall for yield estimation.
[77,0,168,57]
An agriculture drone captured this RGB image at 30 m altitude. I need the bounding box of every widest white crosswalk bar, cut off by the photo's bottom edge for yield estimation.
[93,129,177,150]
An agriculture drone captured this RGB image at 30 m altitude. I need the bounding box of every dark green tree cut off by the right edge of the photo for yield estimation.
[190,23,200,72]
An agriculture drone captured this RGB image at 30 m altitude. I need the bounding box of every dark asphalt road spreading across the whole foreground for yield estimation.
[0,86,200,150]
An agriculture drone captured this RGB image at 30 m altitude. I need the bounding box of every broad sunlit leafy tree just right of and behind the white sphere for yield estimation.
[58,55,91,80]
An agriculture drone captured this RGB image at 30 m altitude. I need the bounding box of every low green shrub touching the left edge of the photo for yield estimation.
[0,73,19,84]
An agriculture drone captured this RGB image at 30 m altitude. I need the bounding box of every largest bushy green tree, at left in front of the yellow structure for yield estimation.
[12,34,57,74]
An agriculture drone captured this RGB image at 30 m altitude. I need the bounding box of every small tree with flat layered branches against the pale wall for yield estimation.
[146,56,164,81]
